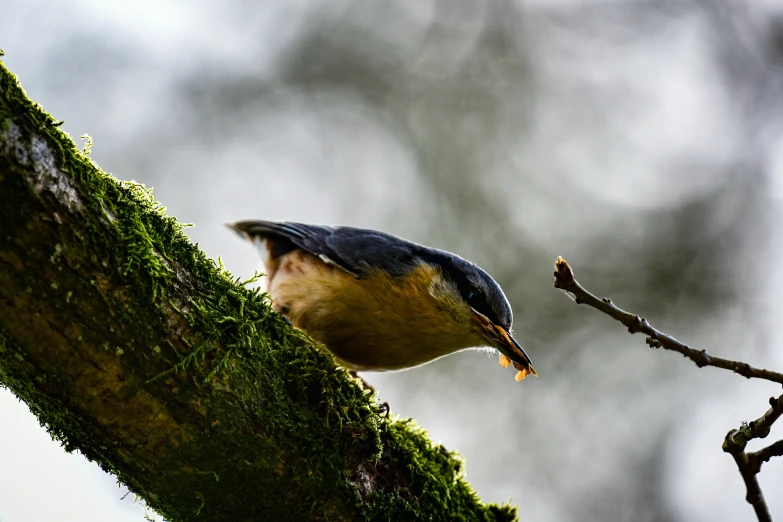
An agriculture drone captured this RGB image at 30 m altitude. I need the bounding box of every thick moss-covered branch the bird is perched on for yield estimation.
[0,63,516,522]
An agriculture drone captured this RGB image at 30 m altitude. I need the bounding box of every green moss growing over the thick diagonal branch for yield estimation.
[0,64,516,521]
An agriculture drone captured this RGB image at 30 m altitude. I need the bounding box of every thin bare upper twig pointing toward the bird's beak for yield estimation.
[555,257,783,384]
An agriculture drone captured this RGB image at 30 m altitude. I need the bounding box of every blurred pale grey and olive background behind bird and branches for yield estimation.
[0,0,783,522]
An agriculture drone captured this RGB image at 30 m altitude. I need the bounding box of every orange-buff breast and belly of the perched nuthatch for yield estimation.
[269,250,483,371]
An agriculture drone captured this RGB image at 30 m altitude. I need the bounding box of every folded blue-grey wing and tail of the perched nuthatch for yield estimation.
[231,220,422,277]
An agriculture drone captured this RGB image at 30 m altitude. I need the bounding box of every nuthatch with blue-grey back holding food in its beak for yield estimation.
[229,220,537,380]
